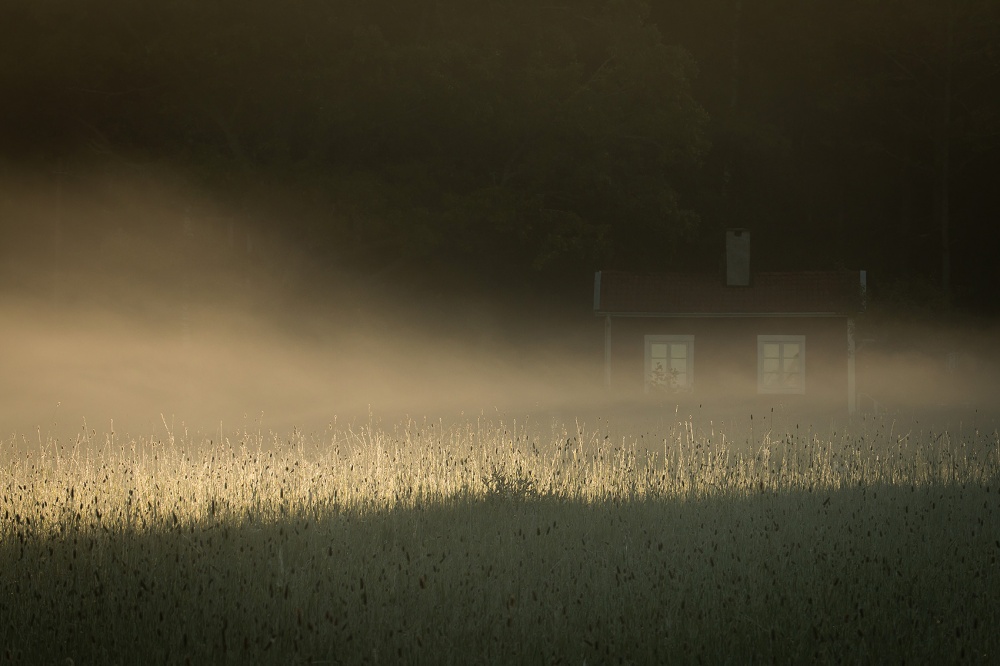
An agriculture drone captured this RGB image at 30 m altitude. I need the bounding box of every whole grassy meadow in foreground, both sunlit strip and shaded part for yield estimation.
[0,412,1000,664]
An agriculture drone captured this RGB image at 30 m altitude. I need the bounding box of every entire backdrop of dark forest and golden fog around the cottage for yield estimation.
[0,0,1000,436]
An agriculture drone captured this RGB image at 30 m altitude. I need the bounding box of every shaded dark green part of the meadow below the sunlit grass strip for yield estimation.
[0,479,1000,664]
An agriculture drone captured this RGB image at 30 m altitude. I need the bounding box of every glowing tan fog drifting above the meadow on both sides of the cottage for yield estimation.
[0,164,1000,439]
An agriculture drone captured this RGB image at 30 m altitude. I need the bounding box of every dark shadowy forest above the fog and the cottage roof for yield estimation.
[0,0,1000,310]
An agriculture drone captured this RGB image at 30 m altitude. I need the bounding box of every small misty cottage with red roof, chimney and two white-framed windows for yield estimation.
[594,229,866,413]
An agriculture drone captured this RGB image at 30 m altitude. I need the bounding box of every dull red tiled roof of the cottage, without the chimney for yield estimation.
[594,271,865,317]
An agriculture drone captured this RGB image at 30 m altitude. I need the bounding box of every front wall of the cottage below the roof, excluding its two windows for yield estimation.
[610,317,848,410]
